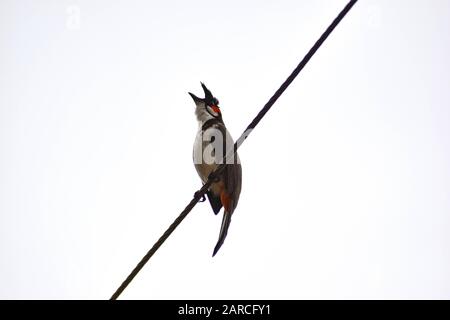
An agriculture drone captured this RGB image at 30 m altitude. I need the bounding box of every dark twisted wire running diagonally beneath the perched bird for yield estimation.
[110,0,357,300]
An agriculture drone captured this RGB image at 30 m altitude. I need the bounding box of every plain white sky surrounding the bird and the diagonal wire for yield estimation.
[0,0,450,299]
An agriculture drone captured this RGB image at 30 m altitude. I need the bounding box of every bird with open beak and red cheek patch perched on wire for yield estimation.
[188,82,242,257]
